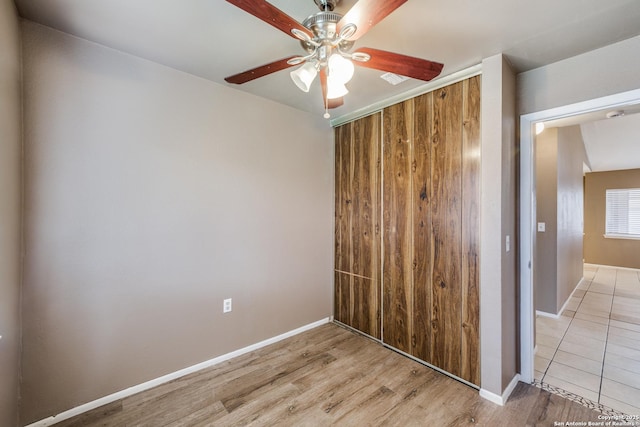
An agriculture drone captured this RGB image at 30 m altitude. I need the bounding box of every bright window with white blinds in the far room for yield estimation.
[605,188,640,239]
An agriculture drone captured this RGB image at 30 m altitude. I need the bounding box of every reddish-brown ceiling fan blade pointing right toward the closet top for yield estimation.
[353,47,444,81]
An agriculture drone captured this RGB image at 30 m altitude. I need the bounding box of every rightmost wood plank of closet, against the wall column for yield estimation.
[460,76,480,385]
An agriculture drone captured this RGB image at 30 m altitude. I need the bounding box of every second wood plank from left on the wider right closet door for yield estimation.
[411,93,433,363]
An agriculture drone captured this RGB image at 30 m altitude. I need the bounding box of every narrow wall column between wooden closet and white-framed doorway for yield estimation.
[480,55,519,396]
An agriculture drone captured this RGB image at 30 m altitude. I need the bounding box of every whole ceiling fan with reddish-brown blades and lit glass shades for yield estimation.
[225,0,443,118]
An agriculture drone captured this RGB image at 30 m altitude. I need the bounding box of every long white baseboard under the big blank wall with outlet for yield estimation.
[25,317,331,427]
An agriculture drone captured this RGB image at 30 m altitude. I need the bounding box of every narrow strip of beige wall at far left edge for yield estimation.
[0,0,22,426]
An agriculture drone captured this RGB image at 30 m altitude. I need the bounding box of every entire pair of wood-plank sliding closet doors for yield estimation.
[335,76,480,385]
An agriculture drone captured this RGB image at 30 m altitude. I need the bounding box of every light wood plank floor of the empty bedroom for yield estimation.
[56,324,599,427]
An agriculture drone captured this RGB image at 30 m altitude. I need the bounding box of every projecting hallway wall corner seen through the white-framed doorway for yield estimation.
[535,126,588,314]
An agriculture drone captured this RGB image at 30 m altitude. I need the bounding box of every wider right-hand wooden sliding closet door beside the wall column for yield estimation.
[382,77,480,384]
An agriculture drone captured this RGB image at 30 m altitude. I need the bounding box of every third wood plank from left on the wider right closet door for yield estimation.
[431,83,462,376]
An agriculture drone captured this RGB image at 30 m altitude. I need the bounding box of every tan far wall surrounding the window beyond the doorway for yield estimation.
[584,169,640,268]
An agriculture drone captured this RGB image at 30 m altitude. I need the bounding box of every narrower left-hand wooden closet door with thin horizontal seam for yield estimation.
[335,113,380,338]
